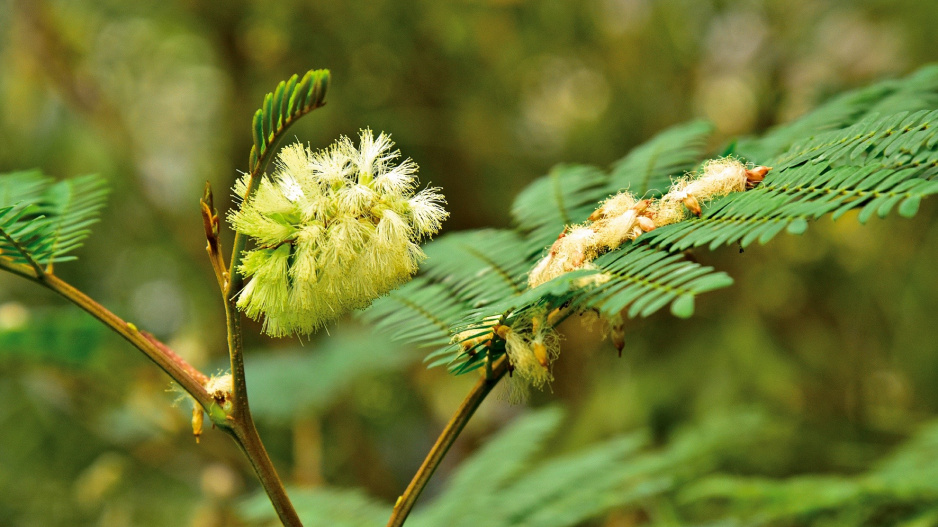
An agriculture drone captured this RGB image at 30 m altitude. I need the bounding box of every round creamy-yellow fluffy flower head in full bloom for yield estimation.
[228,129,448,336]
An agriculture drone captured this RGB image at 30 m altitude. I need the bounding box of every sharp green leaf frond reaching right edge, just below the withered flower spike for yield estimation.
[641,111,938,250]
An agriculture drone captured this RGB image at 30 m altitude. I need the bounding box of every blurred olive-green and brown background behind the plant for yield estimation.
[0,0,938,526]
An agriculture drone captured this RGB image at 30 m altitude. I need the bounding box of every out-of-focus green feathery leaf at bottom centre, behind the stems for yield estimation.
[240,408,765,527]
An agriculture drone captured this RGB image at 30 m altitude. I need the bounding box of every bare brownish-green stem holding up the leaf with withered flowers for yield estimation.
[387,358,508,527]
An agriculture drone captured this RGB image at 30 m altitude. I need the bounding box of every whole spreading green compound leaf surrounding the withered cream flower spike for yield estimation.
[366,67,938,380]
